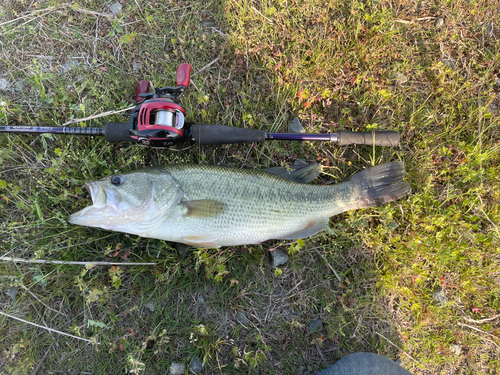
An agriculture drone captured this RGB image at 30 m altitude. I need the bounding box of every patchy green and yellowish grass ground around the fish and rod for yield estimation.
[0,0,500,374]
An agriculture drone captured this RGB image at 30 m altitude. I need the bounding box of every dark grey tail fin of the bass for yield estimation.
[349,161,411,208]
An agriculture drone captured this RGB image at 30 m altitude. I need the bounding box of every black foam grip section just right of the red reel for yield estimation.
[191,125,266,145]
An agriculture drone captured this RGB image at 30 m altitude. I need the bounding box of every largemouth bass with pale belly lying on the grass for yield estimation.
[68,161,411,248]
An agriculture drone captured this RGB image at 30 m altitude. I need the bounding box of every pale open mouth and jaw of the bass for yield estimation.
[68,181,120,226]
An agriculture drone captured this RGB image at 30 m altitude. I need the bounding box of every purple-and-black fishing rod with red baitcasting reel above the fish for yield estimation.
[0,64,400,148]
